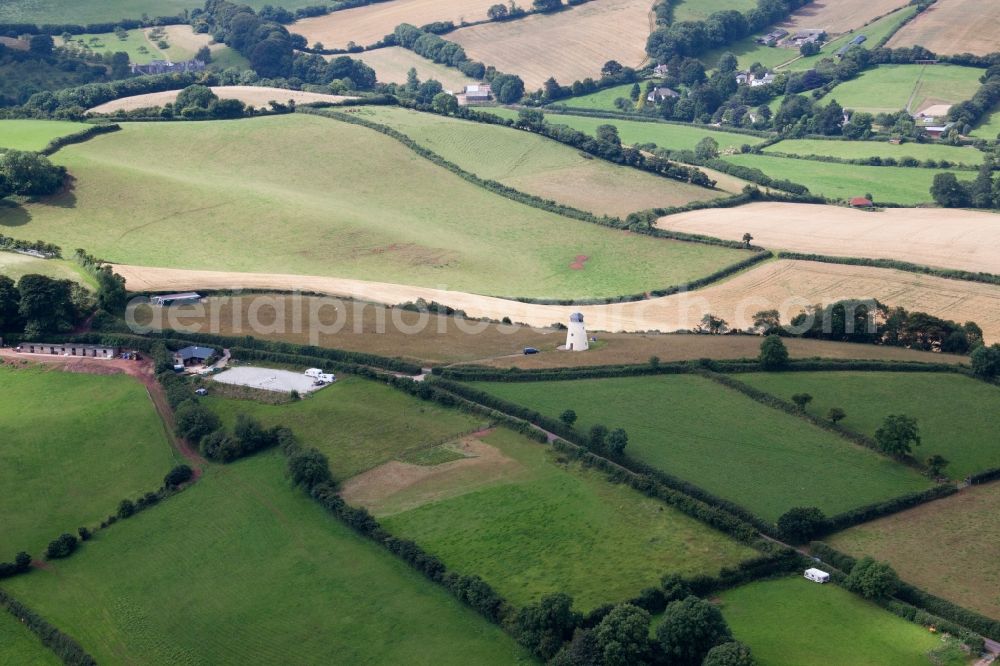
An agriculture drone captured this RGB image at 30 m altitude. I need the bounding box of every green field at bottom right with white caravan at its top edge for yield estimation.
[720,576,965,666]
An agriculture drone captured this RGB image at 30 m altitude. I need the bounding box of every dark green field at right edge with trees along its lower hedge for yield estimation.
[740,372,1000,479]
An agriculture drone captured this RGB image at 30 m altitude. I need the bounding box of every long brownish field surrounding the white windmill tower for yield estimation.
[129,294,968,368]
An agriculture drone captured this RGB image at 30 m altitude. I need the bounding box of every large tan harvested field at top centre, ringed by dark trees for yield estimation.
[447,0,653,90]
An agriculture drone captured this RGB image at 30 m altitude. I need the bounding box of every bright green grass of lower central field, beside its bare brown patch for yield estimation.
[376,429,757,611]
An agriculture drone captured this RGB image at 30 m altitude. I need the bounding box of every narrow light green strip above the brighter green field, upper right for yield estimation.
[764,139,986,166]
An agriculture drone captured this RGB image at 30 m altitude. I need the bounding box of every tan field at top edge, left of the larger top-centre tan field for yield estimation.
[289,0,496,48]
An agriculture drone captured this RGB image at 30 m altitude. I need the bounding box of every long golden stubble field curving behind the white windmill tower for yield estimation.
[115,260,1000,342]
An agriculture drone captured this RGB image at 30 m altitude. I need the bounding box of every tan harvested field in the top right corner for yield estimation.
[886,0,1000,55]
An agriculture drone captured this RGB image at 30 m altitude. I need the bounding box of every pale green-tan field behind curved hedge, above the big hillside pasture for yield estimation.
[358,107,725,217]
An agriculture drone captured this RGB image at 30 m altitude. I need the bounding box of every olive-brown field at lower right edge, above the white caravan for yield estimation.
[827,481,1000,618]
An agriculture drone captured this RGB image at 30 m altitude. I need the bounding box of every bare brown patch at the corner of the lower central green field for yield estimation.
[340,430,522,515]
